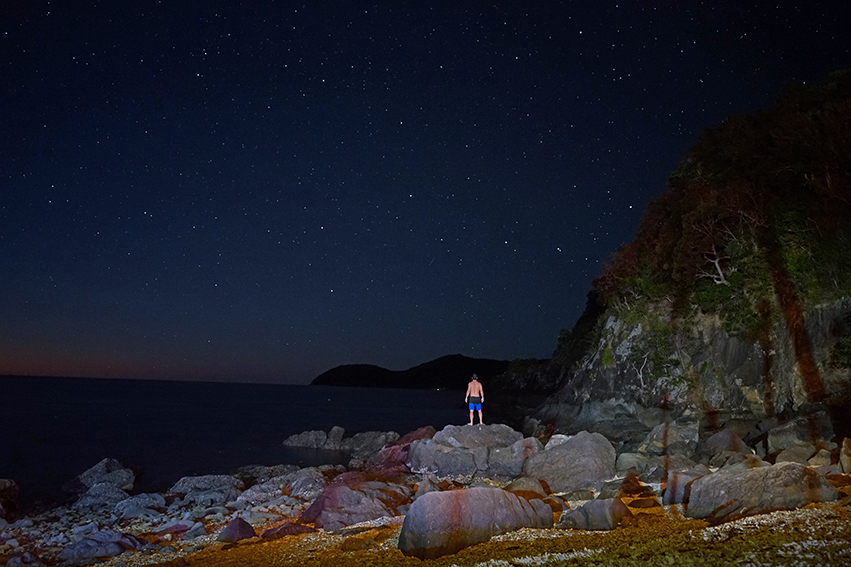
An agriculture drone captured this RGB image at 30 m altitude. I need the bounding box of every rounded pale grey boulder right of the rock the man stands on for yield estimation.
[523,431,615,493]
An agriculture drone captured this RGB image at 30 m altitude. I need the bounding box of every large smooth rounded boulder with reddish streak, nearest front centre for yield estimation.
[399,487,553,559]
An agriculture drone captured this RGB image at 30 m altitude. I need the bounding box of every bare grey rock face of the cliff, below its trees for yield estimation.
[538,298,851,429]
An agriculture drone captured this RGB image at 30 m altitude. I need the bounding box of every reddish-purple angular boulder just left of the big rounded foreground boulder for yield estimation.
[300,473,411,531]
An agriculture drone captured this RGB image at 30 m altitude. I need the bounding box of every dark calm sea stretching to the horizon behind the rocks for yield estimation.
[0,377,467,505]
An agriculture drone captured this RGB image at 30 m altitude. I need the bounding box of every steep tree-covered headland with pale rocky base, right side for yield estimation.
[536,72,851,438]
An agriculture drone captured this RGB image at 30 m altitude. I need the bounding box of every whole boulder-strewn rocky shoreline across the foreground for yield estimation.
[0,414,851,567]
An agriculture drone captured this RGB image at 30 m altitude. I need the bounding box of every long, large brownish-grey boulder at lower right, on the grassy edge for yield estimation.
[686,462,838,520]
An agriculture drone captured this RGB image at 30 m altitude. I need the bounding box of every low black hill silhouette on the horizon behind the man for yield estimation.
[311,354,508,390]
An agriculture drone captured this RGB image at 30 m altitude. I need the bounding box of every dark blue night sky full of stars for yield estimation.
[0,0,851,384]
